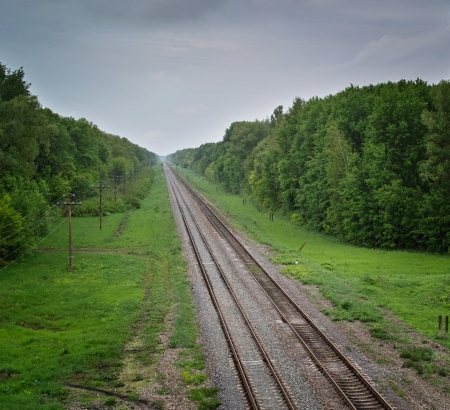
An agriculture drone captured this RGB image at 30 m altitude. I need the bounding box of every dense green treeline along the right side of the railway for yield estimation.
[169,79,450,253]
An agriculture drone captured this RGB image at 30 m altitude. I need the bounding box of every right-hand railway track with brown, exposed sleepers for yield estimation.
[167,167,394,410]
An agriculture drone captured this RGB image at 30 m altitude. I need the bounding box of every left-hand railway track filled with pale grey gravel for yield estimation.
[167,165,298,410]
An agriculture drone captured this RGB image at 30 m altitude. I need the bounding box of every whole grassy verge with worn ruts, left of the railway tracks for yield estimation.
[0,166,217,410]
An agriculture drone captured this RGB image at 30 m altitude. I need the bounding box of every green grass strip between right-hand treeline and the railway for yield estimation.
[181,169,450,347]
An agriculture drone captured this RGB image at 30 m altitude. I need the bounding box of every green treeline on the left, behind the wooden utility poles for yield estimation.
[0,63,157,266]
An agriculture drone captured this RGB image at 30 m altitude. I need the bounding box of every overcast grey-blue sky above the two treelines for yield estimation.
[0,0,450,155]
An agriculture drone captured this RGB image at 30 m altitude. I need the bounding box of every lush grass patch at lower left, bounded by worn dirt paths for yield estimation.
[0,253,146,409]
